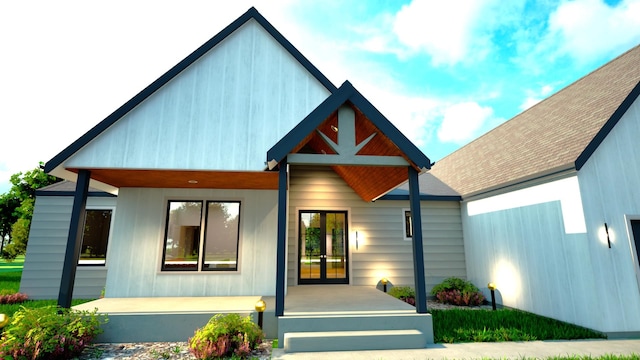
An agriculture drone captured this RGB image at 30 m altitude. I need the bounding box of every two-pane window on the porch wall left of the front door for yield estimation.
[162,201,240,271]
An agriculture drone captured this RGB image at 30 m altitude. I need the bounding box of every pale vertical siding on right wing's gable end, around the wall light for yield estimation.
[578,94,640,333]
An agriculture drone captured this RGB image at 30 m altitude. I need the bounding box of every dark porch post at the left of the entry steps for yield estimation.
[276,158,287,316]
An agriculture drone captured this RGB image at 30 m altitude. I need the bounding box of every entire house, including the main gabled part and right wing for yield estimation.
[21,8,640,336]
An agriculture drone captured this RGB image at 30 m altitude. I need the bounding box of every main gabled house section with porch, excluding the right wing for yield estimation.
[21,8,466,324]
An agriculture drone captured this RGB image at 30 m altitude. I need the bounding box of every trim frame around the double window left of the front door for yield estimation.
[157,197,244,275]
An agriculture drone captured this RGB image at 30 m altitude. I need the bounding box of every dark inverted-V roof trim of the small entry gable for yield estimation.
[267,81,431,169]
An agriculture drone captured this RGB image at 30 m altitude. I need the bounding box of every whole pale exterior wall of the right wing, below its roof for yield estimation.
[463,97,640,333]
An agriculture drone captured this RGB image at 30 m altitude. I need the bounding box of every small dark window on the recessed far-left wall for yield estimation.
[78,210,112,266]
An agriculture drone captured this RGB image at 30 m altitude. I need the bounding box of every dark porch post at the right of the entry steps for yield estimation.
[409,166,427,314]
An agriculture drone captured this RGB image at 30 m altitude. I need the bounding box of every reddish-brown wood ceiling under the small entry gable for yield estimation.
[291,103,410,201]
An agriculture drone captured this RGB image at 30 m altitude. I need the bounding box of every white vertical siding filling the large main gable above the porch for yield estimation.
[66,20,330,170]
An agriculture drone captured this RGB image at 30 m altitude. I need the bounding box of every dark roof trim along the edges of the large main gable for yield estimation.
[44,7,337,172]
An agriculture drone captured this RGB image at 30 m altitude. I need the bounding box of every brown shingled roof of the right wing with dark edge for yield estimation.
[431,46,640,197]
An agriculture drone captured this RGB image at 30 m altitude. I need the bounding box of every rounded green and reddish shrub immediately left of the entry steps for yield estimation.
[189,314,264,359]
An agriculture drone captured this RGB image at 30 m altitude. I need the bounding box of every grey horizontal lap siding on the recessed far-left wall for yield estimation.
[20,196,116,300]
